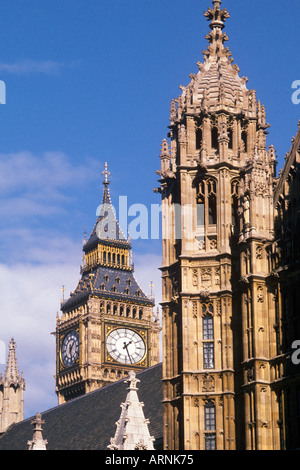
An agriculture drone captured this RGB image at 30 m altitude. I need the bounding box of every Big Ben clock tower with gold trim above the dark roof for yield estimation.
[56,164,161,404]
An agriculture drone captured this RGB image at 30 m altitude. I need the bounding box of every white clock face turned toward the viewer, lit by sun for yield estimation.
[106,328,146,364]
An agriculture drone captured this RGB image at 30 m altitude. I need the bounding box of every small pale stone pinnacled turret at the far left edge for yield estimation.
[0,338,25,433]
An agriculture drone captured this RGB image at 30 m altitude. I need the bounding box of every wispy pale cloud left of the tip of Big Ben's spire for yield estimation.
[0,152,100,218]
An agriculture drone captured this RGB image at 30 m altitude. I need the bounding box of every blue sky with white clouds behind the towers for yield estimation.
[0,0,300,416]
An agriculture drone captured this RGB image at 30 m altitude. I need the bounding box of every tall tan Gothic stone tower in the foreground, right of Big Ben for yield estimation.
[157,0,279,450]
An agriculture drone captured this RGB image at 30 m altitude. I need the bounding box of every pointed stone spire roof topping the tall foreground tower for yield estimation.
[170,0,257,124]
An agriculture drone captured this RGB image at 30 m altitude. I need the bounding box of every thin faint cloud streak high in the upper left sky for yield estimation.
[0,59,74,75]
